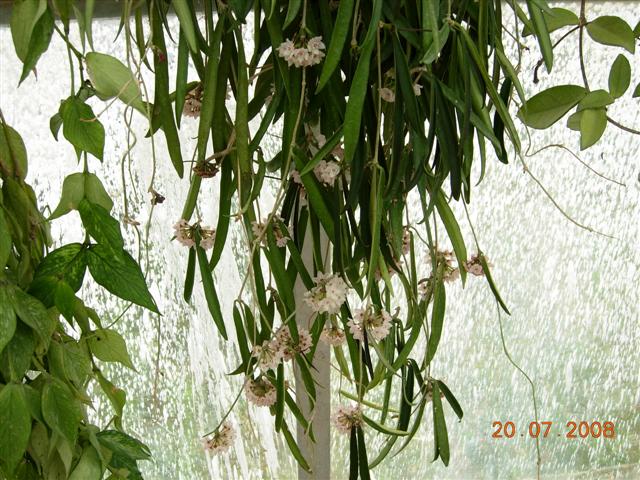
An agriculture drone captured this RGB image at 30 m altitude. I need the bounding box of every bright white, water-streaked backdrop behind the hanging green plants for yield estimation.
[0,2,640,479]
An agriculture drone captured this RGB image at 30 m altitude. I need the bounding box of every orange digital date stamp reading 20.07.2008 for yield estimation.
[491,420,616,439]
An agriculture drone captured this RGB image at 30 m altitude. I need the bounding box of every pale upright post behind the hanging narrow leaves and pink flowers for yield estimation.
[294,231,331,480]
